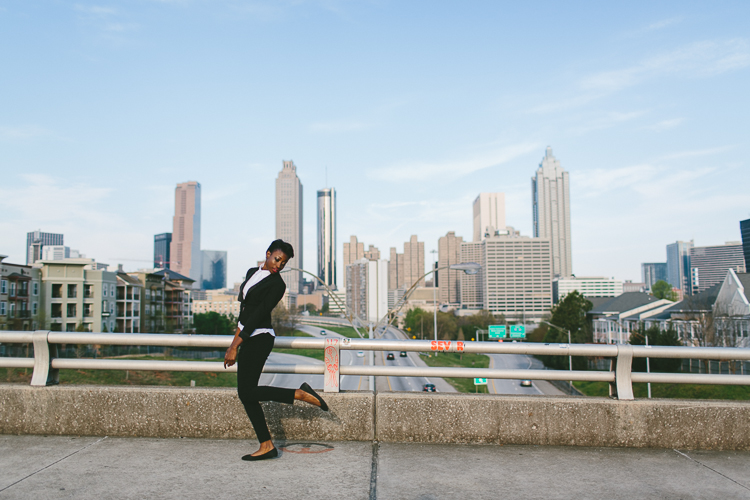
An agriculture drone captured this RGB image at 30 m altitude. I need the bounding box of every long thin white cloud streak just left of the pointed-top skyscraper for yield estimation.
[367,143,541,182]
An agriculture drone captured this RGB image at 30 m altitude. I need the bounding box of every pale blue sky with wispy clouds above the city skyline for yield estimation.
[0,2,750,283]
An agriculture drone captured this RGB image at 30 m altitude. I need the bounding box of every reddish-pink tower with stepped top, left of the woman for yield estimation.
[169,181,203,286]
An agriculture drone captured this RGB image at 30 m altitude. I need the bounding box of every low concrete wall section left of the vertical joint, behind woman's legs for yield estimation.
[0,384,374,441]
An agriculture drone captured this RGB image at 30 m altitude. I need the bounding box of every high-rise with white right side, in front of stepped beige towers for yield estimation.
[346,259,388,322]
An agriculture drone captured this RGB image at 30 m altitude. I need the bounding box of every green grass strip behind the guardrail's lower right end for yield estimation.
[573,382,750,400]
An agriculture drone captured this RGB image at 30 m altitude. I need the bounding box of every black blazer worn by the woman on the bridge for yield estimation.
[237,267,286,340]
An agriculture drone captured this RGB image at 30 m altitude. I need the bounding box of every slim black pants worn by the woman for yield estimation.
[237,333,295,443]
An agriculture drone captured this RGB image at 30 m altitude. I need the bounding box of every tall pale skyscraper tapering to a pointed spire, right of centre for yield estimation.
[531,147,573,277]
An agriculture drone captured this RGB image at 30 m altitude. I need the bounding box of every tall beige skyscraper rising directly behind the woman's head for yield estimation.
[276,160,305,294]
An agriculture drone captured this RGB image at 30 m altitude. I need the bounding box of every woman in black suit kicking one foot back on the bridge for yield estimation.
[224,240,328,461]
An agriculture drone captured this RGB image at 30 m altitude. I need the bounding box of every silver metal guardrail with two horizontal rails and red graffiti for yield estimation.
[0,330,750,400]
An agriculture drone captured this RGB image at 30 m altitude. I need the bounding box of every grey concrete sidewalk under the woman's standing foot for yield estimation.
[0,435,750,500]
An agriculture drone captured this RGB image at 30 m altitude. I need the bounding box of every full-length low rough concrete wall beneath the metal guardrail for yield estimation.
[0,384,750,450]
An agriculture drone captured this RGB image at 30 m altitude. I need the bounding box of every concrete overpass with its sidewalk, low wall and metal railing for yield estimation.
[0,332,750,498]
